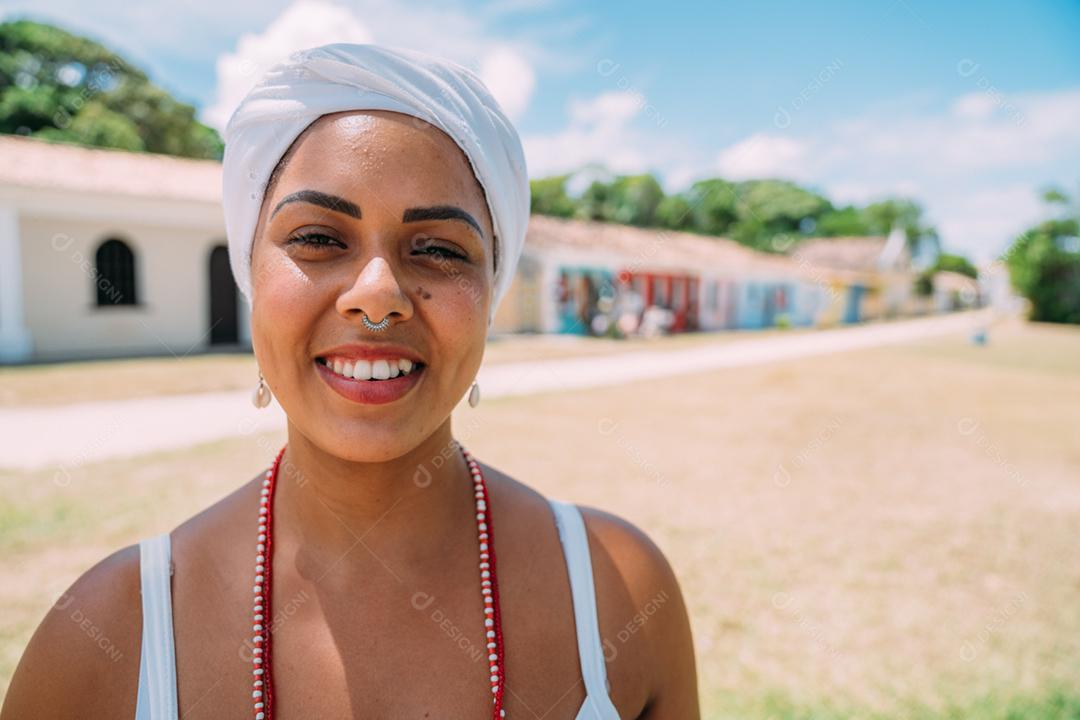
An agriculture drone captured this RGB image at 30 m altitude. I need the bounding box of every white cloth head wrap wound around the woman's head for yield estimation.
[222,43,529,325]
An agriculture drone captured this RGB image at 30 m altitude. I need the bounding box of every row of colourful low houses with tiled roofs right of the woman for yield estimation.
[492,216,916,335]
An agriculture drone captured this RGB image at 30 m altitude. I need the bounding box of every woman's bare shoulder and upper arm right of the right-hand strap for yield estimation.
[579,505,700,720]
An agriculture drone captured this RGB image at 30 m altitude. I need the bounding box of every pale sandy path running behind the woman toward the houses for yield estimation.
[0,313,984,475]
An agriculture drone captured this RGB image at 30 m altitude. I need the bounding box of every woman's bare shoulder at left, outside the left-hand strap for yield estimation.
[0,545,143,720]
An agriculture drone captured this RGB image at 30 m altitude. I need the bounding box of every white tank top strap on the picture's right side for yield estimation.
[549,499,619,720]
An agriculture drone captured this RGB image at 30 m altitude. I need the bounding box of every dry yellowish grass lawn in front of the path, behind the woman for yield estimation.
[0,317,1080,720]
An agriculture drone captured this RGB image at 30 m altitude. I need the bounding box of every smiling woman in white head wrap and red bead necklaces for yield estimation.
[2,44,699,720]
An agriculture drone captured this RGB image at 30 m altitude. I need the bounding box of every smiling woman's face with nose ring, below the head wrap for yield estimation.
[252,110,494,462]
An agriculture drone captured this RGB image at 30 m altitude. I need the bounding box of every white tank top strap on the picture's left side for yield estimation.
[135,532,178,720]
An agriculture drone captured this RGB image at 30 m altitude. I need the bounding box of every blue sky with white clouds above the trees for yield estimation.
[3,0,1080,260]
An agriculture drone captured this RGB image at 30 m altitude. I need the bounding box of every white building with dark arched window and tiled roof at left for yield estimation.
[0,135,251,363]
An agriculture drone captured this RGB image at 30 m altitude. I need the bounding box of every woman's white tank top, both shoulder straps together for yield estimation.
[135,499,619,720]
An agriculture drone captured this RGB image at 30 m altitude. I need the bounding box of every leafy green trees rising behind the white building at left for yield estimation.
[0,19,224,159]
